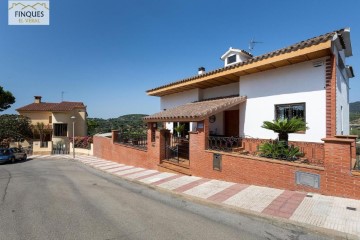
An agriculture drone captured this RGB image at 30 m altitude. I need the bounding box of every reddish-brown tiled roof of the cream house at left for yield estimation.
[16,102,85,112]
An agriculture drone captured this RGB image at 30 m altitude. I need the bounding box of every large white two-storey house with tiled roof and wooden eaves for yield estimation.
[145,28,354,142]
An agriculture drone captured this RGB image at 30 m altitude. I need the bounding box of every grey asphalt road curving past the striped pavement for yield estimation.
[0,159,344,240]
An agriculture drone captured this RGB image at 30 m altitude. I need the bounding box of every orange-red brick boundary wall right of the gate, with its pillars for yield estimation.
[190,121,360,199]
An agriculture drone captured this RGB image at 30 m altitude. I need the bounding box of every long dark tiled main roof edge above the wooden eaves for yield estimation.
[146,29,346,92]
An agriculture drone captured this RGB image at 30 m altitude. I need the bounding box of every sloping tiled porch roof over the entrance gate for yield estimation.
[144,96,246,122]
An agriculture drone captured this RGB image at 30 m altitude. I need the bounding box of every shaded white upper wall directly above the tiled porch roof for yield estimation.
[160,88,200,111]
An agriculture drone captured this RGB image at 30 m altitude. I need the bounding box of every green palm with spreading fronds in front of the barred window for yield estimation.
[261,118,309,145]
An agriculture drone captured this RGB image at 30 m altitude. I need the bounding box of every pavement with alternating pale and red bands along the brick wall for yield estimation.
[30,155,360,239]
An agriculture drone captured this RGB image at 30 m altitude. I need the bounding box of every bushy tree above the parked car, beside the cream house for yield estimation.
[0,114,33,142]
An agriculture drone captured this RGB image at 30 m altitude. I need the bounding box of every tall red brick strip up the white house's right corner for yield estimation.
[326,55,336,138]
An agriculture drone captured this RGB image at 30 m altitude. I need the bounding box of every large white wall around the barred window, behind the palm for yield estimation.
[240,58,326,142]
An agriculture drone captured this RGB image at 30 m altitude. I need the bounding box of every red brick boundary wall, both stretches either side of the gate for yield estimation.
[94,120,360,199]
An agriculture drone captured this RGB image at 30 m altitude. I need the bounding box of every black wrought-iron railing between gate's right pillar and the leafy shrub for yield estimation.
[208,136,242,152]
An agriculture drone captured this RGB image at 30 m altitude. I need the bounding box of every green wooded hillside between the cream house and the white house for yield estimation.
[88,114,147,135]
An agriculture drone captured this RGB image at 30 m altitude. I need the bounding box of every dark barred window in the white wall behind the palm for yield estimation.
[275,103,306,121]
